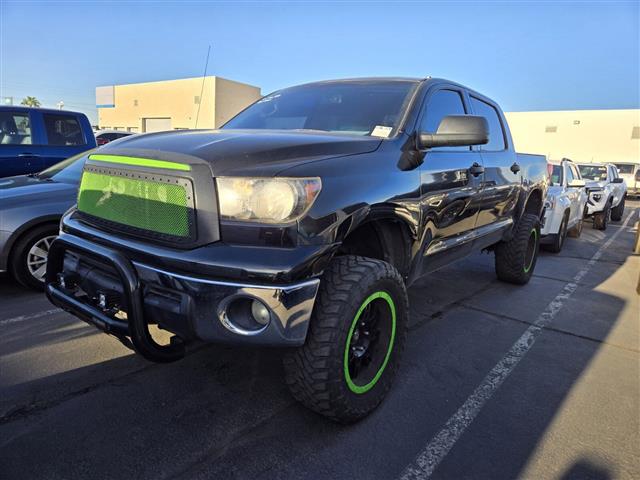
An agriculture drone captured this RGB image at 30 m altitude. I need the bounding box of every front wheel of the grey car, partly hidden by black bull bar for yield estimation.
[9,224,58,290]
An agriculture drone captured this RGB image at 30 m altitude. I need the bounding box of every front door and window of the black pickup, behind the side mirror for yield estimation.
[417,86,483,273]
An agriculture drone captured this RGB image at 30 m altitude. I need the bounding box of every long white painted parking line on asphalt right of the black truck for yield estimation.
[400,211,635,480]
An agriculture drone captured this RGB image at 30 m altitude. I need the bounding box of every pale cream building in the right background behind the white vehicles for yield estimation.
[505,110,640,163]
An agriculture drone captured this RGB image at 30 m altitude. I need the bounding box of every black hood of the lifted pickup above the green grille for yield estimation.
[99,130,382,176]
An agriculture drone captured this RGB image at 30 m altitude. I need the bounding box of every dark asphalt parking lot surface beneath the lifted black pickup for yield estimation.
[0,201,640,479]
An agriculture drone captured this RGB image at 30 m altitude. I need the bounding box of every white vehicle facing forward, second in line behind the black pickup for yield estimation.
[578,163,627,230]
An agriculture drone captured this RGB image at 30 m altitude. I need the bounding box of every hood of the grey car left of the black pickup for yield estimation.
[0,175,78,210]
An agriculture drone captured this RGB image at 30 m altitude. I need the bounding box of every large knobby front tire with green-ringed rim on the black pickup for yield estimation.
[284,255,409,423]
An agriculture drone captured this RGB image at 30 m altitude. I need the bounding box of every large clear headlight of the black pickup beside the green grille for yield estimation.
[216,177,322,223]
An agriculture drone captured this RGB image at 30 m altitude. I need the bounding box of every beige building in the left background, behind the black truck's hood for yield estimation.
[96,76,260,133]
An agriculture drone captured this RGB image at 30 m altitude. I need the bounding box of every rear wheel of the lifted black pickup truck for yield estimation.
[495,214,540,285]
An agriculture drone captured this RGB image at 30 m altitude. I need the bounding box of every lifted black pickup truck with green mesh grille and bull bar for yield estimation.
[46,78,547,422]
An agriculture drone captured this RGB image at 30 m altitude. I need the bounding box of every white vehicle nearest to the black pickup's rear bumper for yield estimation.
[540,158,587,253]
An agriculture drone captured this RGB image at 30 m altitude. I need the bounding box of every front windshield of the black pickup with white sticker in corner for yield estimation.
[222,80,418,137]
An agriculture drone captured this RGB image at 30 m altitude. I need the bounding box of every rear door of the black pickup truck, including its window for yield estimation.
[469,93,521,231]
